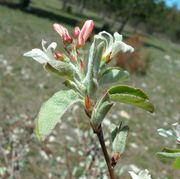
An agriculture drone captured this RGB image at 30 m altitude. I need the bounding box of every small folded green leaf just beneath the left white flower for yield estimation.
[45,60,74,79]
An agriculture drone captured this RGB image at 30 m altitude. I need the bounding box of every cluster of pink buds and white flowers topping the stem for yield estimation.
[24,20,134,103]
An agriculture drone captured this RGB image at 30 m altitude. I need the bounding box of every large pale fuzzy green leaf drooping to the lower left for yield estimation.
[35,90,79,139]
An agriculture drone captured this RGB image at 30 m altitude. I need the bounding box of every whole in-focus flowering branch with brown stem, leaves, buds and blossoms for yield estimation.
[24,20,154,179]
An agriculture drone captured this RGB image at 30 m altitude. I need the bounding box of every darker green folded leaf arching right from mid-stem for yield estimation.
[108,86,154,112]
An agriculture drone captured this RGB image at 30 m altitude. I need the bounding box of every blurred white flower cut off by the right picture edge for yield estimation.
[157,122,180,144]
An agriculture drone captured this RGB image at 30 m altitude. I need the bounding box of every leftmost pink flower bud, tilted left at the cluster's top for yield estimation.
[53,24,72,43]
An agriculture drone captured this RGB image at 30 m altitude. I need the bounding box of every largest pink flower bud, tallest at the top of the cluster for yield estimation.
[78,20,94,46]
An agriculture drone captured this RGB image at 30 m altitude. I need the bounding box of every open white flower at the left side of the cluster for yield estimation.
[24,40,57,64]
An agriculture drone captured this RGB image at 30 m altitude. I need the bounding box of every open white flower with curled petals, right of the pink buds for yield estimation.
[95,31,134,59]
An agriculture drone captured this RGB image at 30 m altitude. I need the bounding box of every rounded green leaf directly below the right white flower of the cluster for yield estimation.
[99,67,129,85]
